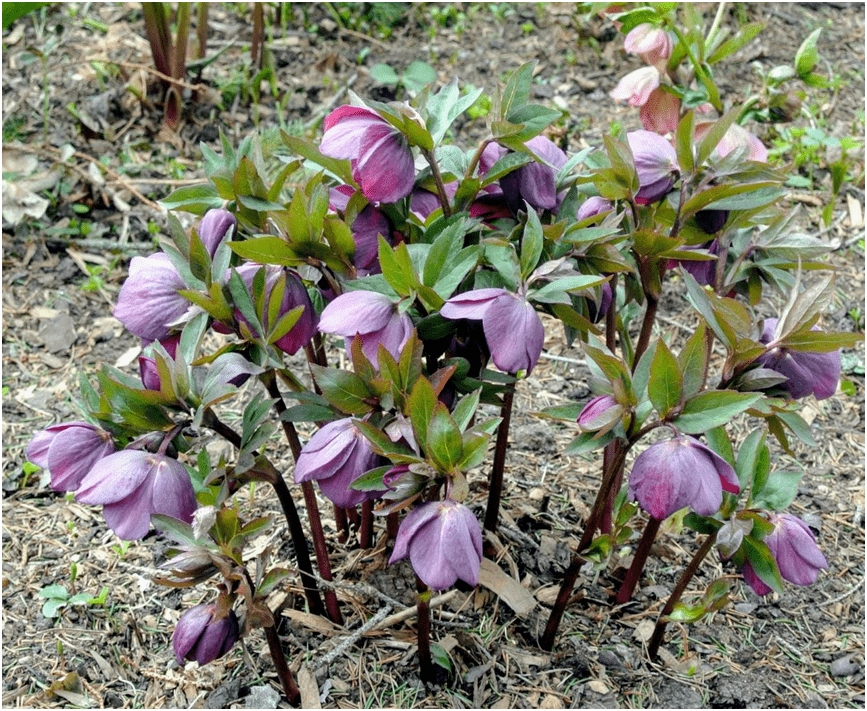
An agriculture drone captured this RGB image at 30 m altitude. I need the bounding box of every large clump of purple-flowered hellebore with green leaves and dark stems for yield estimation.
[27,3,859,704]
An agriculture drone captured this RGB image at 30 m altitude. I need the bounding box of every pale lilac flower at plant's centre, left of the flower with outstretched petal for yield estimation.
[319,291,413,363]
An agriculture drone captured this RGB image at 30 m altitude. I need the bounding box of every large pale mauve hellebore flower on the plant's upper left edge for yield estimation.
[114,252,190,342]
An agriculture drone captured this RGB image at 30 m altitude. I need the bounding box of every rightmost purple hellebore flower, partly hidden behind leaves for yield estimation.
[756,318,841,400]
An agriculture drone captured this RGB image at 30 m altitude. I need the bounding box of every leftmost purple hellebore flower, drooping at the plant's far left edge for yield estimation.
[26,422,115,491]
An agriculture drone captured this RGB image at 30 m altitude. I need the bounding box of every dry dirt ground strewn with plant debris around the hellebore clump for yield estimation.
[2,3,865,709]
